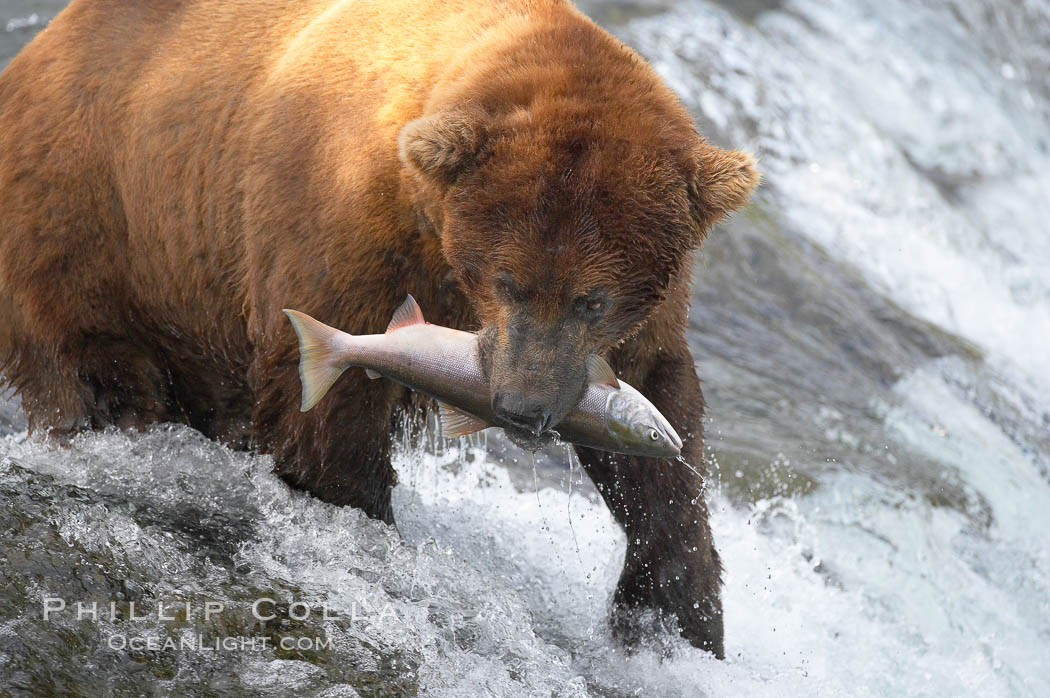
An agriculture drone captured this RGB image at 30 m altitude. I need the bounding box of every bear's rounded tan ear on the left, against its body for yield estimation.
[398,109,487,187]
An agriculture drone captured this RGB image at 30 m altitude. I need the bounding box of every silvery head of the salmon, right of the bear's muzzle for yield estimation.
[606,381,681,458]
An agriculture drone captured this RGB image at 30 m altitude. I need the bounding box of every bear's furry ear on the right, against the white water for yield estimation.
[689,142,762,234]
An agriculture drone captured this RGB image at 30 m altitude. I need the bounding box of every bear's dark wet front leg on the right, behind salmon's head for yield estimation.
[576,348,725,658]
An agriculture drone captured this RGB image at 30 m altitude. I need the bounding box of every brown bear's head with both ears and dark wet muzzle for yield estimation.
[399,104,758,445]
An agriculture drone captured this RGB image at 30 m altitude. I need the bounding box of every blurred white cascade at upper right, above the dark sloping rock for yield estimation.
[625,0,1050,393]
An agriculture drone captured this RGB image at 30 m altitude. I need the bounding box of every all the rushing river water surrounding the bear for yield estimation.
[6,0,1050,696]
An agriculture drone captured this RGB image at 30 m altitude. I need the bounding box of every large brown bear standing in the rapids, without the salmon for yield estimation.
[0,0,758,656]
